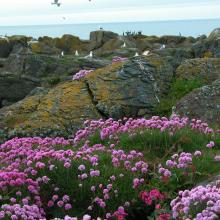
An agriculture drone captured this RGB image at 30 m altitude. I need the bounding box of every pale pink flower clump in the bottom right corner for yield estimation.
[171,181,220,220]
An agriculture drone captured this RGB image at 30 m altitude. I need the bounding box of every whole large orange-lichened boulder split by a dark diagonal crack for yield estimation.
[0,56,173,140]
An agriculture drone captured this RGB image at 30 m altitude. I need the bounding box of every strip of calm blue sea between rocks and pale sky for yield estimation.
[0,19,220,40]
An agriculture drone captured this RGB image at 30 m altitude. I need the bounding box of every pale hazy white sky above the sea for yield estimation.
[0,0,220,26]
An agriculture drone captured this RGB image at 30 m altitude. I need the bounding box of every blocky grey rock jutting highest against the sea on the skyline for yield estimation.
[89,30,118,50]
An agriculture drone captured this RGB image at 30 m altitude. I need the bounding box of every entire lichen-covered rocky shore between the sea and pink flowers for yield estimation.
[0,29,220,141]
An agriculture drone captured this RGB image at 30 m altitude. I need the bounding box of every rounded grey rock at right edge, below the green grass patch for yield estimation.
[175,79,220,124]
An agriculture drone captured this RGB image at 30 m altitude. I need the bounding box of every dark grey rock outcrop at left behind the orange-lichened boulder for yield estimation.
[0,47,110,107]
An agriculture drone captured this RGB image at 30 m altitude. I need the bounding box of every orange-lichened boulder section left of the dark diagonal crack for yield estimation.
[0,81,101,136]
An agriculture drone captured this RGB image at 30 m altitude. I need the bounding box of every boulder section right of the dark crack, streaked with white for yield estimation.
[86,56,173,118]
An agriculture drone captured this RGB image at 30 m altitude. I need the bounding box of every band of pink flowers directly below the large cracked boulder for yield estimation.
[74,116,192,144]
